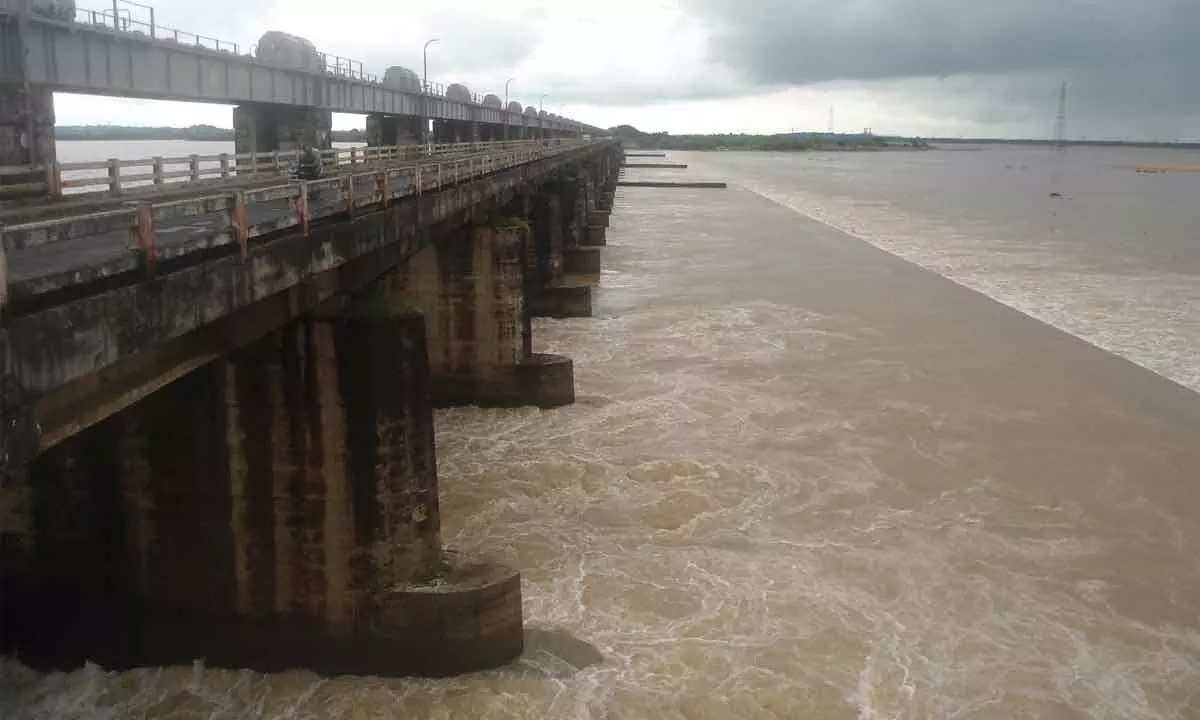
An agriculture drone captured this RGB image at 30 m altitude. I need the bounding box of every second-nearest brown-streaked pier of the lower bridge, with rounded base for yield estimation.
[385,223,575,408]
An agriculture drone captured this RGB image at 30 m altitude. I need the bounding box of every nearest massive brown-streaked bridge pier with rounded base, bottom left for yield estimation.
[0,314,522,676]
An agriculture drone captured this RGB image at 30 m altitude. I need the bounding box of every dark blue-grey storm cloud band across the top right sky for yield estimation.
[684,0,1200,84]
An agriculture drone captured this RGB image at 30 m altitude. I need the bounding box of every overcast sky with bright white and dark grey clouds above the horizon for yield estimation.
[56,0,1200,139]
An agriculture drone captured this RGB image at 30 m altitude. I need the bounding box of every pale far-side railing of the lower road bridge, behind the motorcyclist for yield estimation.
[0,140,561,197]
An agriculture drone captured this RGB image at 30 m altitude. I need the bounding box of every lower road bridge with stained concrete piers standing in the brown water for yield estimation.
[0,123,622,674]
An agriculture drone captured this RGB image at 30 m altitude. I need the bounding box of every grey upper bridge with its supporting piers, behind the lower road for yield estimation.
[0,0,599,192]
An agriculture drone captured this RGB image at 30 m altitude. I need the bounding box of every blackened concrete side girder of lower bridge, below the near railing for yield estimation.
[0,145,614,464]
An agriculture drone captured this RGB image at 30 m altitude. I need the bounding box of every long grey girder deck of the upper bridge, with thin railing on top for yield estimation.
[0,4,590,133]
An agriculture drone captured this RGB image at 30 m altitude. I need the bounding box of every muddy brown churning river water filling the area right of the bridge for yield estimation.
[0,150,1200,720]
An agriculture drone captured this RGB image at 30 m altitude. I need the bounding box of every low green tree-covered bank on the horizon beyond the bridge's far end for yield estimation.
[610,125,928,152]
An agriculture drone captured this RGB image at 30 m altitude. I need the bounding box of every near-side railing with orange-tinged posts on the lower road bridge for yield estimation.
[0,139,594,306]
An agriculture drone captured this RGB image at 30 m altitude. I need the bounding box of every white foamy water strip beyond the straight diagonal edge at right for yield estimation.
[692,161,1200,391]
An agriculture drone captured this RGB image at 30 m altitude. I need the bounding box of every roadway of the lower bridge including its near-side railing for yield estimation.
[0,140,581,301]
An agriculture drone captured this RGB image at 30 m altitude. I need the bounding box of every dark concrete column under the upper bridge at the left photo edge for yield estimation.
[0,85,55,198]
